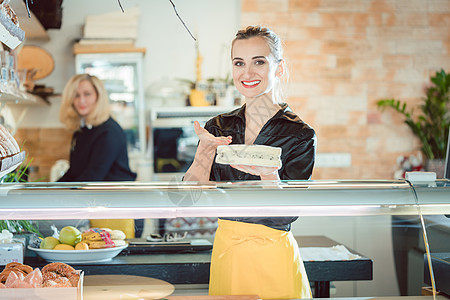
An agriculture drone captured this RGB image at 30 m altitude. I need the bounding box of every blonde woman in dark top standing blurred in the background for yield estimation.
[58,74,136,238]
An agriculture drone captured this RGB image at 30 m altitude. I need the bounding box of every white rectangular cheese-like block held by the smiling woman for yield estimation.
[216,145,281,168]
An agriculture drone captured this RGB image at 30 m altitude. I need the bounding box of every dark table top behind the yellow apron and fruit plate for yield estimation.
[24,236,373,284]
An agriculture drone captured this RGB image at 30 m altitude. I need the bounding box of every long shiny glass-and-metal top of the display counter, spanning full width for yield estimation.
[0,180,450,220]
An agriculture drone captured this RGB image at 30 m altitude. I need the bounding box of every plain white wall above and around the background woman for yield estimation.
[20,0,241,127]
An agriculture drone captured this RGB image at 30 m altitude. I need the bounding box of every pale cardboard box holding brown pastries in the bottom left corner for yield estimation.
[0,272,84,300]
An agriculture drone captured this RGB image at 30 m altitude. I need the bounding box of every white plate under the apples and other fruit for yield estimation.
[28,245,128,264]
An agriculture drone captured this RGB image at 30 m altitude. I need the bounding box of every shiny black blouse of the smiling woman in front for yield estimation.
[205,104,316,231]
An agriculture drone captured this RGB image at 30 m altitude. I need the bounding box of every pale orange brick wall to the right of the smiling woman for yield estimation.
[241,0,450,179]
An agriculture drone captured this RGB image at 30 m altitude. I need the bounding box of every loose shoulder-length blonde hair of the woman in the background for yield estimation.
[59,74,110,131]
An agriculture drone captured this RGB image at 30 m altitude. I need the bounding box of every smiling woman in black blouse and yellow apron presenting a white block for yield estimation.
[184,26,316,299]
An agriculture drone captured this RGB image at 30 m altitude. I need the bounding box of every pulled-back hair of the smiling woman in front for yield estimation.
[231,26,289,103]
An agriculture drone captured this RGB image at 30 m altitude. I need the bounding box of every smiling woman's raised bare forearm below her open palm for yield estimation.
[183,142,216,181]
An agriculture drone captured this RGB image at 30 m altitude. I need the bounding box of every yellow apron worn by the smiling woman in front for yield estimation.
[209,219,312,299]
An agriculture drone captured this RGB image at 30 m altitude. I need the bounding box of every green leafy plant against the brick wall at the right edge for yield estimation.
[377,69,450,173]
